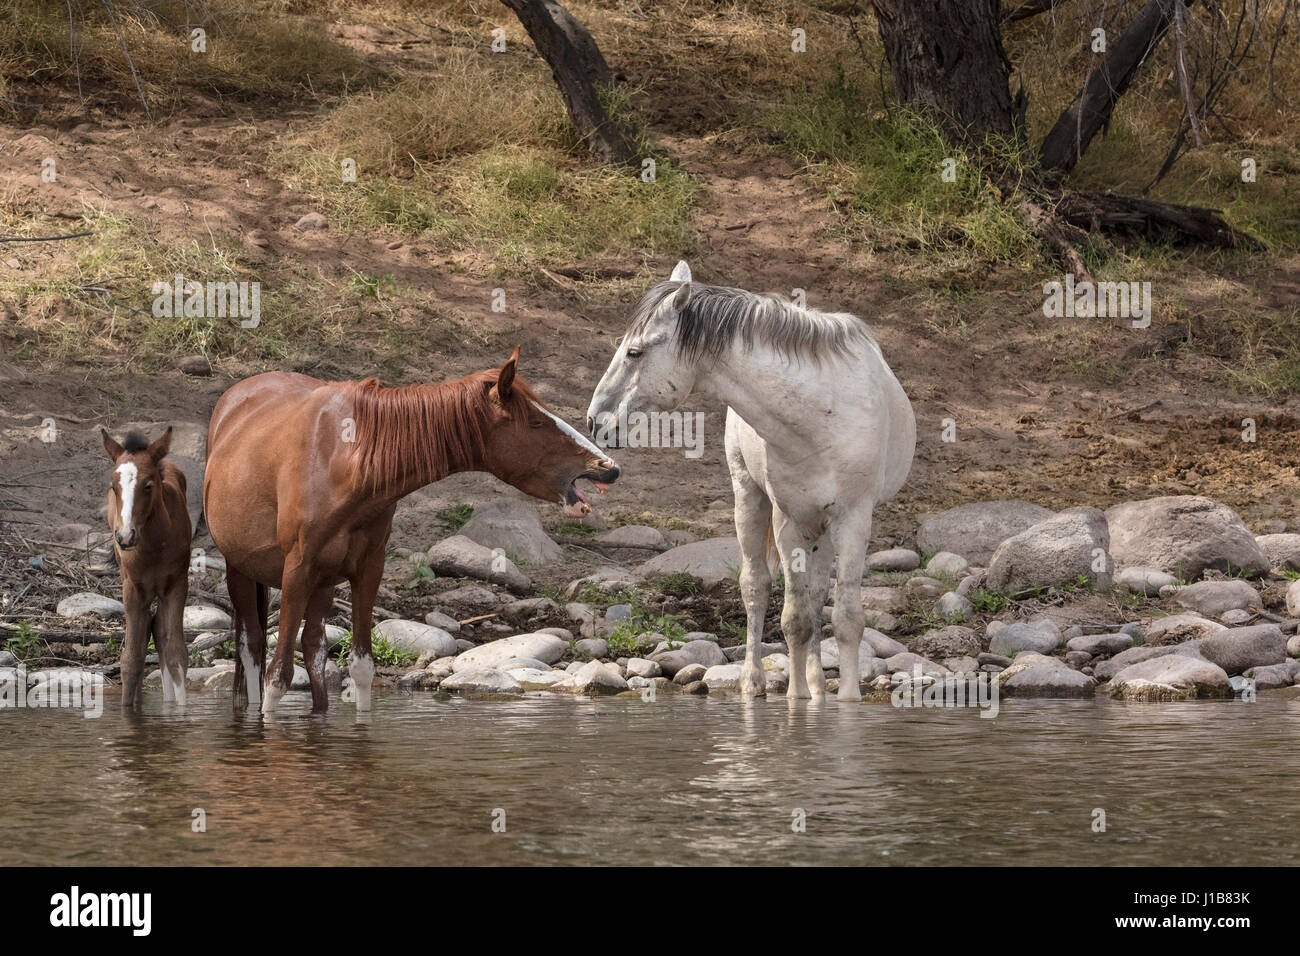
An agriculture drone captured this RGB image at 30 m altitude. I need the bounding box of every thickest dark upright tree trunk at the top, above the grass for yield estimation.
[871,0,1024,142]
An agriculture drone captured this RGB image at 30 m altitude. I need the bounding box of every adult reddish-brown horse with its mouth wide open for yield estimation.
[203,347,619,713]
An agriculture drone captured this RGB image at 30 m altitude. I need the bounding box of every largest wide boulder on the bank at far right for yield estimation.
[1106,494,1269,580]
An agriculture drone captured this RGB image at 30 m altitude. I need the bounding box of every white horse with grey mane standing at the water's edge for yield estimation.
[586,261,917,701]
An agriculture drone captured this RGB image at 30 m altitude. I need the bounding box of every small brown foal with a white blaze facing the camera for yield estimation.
[99,428,190,709]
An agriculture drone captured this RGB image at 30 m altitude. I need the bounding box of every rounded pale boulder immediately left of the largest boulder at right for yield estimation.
[985,507,1112,591]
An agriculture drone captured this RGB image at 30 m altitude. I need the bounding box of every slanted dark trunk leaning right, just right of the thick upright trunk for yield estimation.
[1039,0,1192,173]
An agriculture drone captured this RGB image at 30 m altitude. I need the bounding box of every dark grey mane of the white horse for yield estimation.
[628,280,875,362]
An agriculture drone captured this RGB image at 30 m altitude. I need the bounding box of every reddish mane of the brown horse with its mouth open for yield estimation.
[350,368,545,490]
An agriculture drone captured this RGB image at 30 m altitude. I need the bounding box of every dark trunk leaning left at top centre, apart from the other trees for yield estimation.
[501,0,636,164]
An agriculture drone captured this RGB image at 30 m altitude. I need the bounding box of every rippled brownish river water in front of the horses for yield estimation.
[0,693,1300,865]
